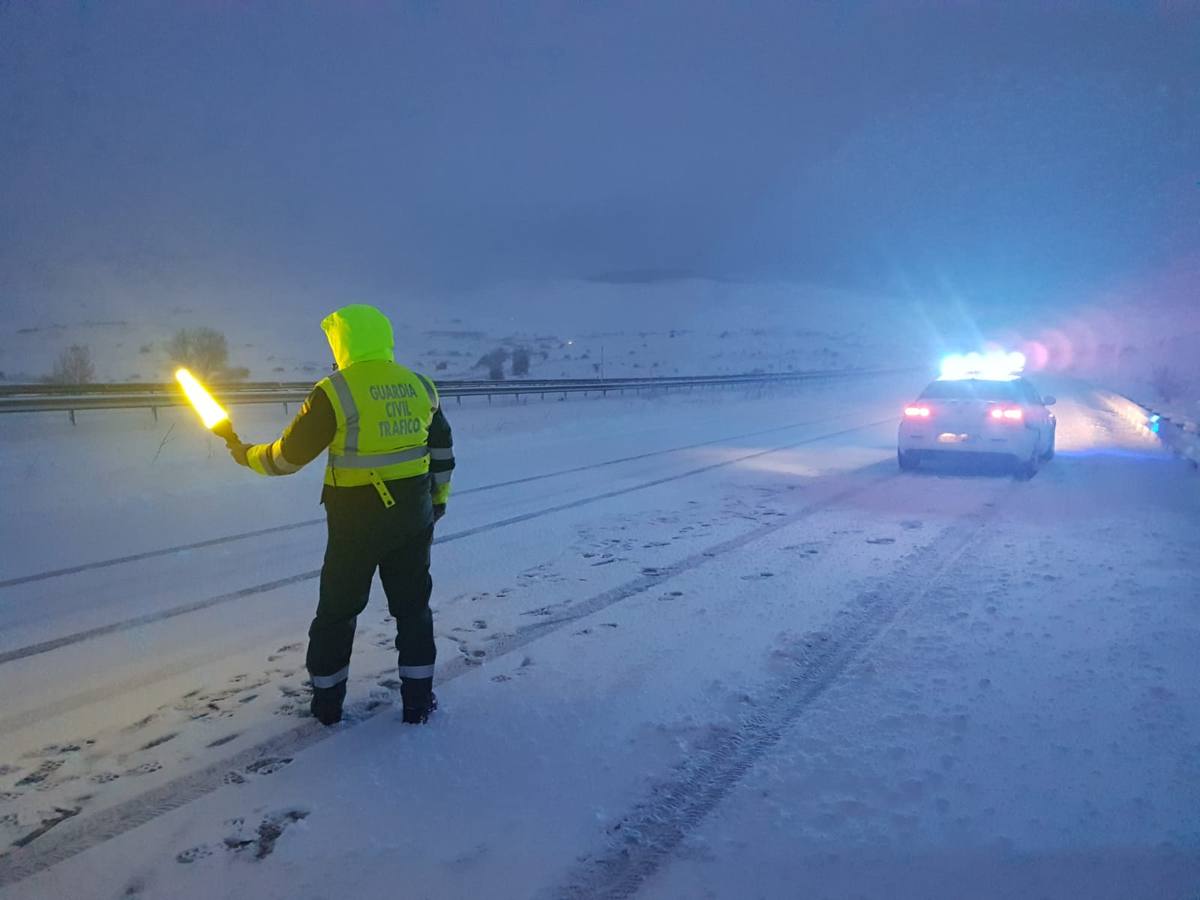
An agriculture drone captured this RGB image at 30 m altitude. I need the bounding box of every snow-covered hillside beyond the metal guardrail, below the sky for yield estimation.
[0,278,926,384]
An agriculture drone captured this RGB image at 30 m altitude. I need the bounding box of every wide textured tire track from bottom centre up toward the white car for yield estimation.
[545,494,1014,900]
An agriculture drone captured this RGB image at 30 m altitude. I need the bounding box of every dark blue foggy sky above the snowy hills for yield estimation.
[0,0,1200,304]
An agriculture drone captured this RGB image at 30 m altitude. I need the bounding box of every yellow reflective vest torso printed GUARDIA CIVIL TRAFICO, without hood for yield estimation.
[317,359,438,506]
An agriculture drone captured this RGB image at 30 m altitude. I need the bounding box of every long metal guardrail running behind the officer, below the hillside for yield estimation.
[0,368,911,424]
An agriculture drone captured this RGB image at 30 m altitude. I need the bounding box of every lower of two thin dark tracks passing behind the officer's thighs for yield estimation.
[0,419,892,666]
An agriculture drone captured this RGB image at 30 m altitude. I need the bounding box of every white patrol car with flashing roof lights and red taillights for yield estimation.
[896,353,1057,478]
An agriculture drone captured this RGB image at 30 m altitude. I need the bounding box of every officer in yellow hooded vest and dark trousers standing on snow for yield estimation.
[230,305,454,725]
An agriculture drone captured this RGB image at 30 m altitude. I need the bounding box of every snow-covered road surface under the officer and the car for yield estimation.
[0,376,1200,899]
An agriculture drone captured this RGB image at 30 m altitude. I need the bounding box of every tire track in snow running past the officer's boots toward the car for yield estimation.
[0,458,901,887]
